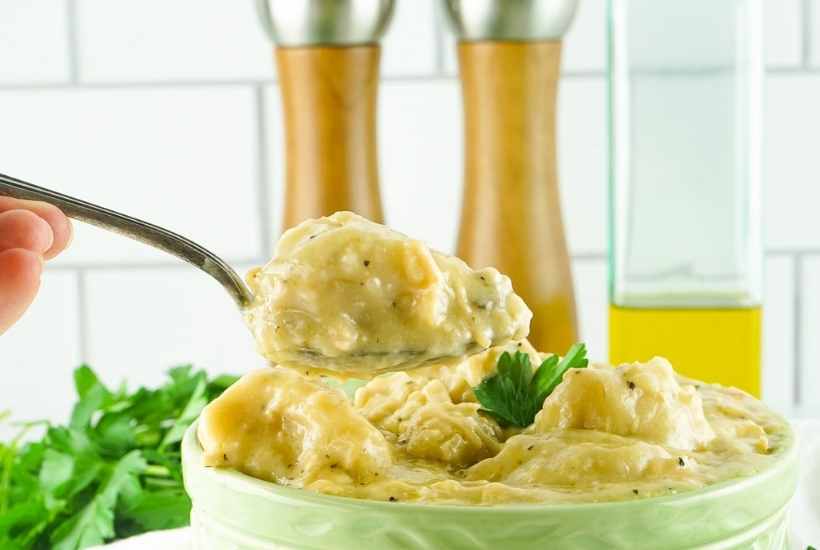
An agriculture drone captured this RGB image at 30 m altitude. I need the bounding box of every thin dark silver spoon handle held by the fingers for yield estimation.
[0,174,253,309]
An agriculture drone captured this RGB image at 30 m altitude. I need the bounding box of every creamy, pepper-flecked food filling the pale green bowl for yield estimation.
[199,352,791,505]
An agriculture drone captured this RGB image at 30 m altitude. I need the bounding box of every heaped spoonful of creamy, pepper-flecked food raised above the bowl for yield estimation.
[246,212,532,374]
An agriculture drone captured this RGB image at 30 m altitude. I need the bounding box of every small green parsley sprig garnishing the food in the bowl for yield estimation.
[473,344,589,428]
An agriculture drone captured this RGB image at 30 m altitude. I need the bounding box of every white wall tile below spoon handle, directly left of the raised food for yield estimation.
[82,266,264,385]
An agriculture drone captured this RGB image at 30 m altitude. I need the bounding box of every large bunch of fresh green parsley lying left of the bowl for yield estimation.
[0,366,236,550]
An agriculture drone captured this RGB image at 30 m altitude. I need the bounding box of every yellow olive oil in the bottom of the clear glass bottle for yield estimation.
[609,305,761,397]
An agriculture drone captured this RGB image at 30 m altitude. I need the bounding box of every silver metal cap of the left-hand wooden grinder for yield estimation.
[257,0,394,46]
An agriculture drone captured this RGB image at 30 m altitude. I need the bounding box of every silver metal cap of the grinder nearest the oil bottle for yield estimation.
[445,0,576,42]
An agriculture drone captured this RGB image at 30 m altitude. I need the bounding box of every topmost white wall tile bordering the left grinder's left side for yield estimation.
[73,0,273,82]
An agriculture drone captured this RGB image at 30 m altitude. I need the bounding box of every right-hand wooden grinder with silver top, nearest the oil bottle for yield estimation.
[446,0,578,353]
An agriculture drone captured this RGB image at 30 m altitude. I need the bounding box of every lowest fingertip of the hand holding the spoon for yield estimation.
[0,248,43,334]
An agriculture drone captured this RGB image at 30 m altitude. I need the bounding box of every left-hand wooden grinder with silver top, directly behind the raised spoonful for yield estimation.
[258,0,393,229]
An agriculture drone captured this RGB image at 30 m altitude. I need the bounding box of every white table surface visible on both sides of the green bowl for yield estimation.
[105,420,820,550]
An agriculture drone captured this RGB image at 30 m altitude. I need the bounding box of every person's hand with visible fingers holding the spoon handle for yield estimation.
[0,197,72,334]
